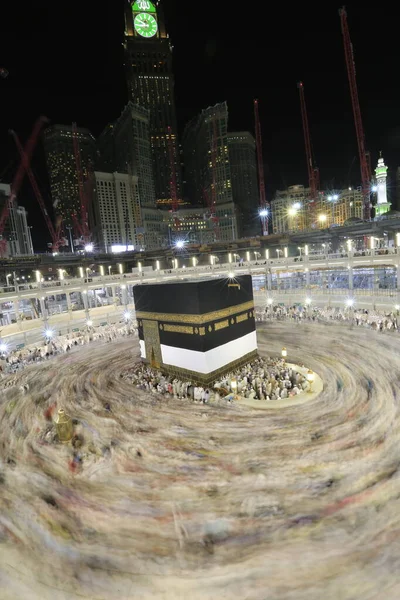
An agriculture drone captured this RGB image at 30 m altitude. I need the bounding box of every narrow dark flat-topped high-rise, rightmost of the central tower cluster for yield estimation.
[228,131,261,237]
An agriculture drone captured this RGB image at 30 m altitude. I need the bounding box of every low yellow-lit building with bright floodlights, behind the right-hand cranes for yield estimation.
[271,185,363,233]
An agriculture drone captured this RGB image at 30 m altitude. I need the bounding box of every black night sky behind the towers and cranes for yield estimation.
[0,0,400,249]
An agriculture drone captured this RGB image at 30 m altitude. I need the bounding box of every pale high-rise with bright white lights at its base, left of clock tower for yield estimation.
[91,171,141,252]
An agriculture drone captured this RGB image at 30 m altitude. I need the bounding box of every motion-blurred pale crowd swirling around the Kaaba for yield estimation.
[0,322,400,600]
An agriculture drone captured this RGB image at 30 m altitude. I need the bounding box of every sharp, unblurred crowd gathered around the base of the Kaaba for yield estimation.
[124,357,310,404]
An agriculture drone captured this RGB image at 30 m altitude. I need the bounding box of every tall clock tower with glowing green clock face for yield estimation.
[124,0,181,207]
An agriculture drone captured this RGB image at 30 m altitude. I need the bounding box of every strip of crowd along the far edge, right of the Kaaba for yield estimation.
[255,305,400,332]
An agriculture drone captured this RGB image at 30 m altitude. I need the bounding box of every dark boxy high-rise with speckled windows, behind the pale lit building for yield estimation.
[43,125,96,227]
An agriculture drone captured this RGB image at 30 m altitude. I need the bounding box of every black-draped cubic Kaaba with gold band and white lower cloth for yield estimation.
[133,275,257,385]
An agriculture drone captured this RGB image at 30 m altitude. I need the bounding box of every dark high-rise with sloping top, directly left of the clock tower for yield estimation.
[97,102,156,207]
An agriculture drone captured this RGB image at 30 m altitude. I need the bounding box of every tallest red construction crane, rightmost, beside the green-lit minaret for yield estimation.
[339,7,371,221]
